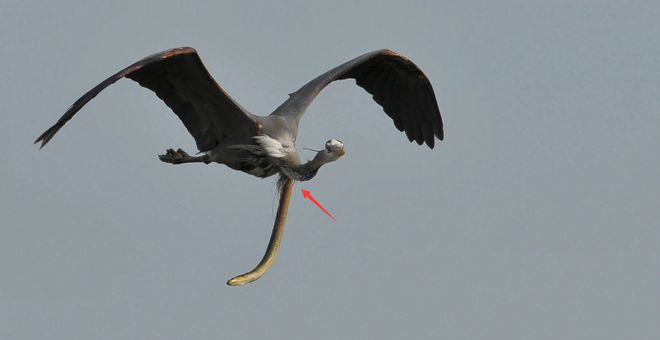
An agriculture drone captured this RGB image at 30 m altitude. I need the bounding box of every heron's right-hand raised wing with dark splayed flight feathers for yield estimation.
[272,49,444,148]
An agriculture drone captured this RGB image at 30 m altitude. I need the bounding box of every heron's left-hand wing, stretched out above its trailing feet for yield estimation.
[35,47,255,151]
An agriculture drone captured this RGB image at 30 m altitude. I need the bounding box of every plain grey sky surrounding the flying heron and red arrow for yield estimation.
[0,0,660,339]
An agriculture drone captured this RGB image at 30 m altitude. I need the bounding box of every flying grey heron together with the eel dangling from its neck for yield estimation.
[34,47,444,286]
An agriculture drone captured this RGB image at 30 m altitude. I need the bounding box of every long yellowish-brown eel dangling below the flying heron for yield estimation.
[227,178,293,286]
